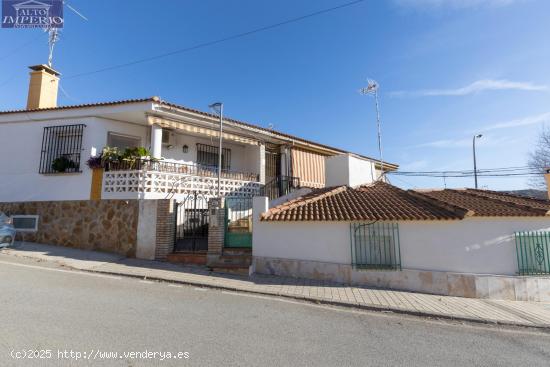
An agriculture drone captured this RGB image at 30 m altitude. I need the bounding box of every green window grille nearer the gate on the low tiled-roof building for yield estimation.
[350,222,401,270]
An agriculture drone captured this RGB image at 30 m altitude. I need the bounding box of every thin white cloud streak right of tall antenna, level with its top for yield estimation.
[391,79,548,97]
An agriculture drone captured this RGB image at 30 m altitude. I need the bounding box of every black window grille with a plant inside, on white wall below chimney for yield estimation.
[38,124,86,173]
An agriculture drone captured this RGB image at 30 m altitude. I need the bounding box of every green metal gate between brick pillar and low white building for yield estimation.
[224,197,252,248]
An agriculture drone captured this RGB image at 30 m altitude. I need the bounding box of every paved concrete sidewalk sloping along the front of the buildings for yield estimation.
[0,243,550,330]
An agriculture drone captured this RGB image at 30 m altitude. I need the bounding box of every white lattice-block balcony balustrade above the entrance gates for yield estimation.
[102,160,261,199]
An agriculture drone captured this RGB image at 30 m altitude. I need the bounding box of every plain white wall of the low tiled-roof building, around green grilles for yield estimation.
[252,198,550,275]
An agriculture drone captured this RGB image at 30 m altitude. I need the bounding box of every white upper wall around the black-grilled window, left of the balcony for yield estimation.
[0,117,147,202]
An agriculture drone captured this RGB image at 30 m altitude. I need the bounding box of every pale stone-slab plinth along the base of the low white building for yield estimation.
[252,256,550,302]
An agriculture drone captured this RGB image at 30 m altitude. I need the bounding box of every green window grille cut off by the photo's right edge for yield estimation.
[515,231,550,275]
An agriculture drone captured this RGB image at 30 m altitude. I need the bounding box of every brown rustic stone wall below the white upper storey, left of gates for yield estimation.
[0,200,175,260]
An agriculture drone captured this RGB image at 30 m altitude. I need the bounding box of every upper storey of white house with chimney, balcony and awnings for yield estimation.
[0,65,397,206]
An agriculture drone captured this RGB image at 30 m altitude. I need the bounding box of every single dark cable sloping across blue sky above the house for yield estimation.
[64,0,365,80]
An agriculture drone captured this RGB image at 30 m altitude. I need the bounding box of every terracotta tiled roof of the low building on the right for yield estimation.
[261,182,550,221]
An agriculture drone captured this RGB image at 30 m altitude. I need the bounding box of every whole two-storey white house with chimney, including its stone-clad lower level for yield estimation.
[0,65,397,263]
